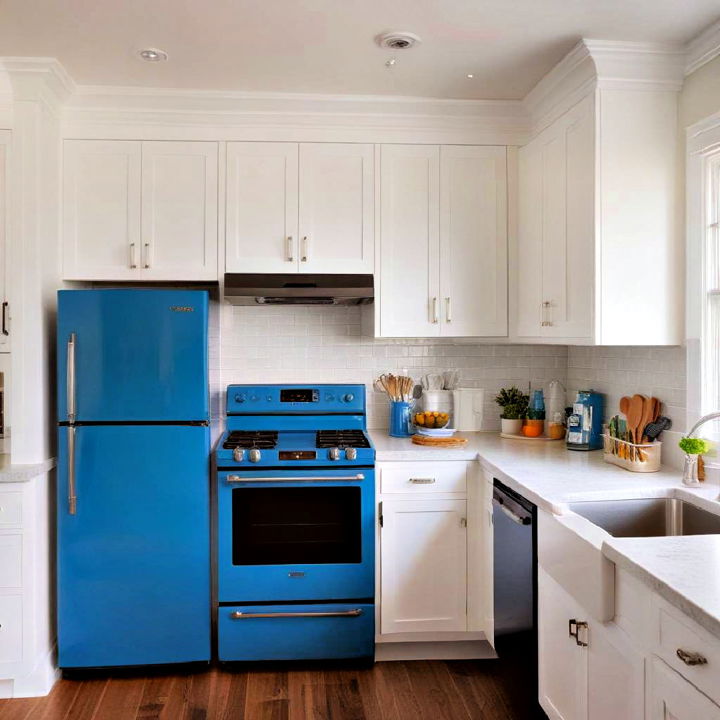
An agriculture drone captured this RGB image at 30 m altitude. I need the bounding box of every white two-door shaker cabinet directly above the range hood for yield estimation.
[225,142,375,274]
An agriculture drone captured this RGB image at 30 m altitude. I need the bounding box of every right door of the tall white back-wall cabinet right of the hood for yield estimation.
[440,145,507,337]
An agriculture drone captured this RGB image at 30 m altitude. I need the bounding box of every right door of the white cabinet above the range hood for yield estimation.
[299,143,375,273]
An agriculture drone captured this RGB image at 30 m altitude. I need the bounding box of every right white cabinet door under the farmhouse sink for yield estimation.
[587,623,645,720]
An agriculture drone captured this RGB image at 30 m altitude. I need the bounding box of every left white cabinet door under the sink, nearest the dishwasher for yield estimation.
[538,568,588,720]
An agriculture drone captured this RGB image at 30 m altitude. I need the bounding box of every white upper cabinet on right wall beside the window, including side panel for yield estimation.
[510,88,684,345]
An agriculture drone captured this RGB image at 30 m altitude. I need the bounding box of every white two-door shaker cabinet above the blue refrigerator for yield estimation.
[63,140,218,281]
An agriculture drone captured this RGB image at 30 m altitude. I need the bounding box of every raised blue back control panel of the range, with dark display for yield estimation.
[226,385,365,415]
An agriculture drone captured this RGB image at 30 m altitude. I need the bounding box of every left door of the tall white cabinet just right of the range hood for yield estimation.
[378,145,440,337]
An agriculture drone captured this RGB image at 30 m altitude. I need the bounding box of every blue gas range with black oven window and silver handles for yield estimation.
[215,385,375,661]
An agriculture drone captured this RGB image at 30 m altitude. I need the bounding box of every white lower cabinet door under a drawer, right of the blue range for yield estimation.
[380,500,467,634]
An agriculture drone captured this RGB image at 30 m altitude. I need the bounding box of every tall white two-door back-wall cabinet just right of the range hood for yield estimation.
[376,145,507,337]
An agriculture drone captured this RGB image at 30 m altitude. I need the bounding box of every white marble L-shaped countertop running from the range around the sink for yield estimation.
[370,431,720,637]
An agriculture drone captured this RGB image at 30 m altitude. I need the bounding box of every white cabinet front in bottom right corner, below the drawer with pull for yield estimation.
[647,657,720,720]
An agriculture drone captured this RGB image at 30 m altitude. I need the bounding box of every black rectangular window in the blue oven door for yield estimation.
[232,487,361,565]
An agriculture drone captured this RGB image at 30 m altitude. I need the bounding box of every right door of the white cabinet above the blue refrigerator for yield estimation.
[140,142,218,280]
